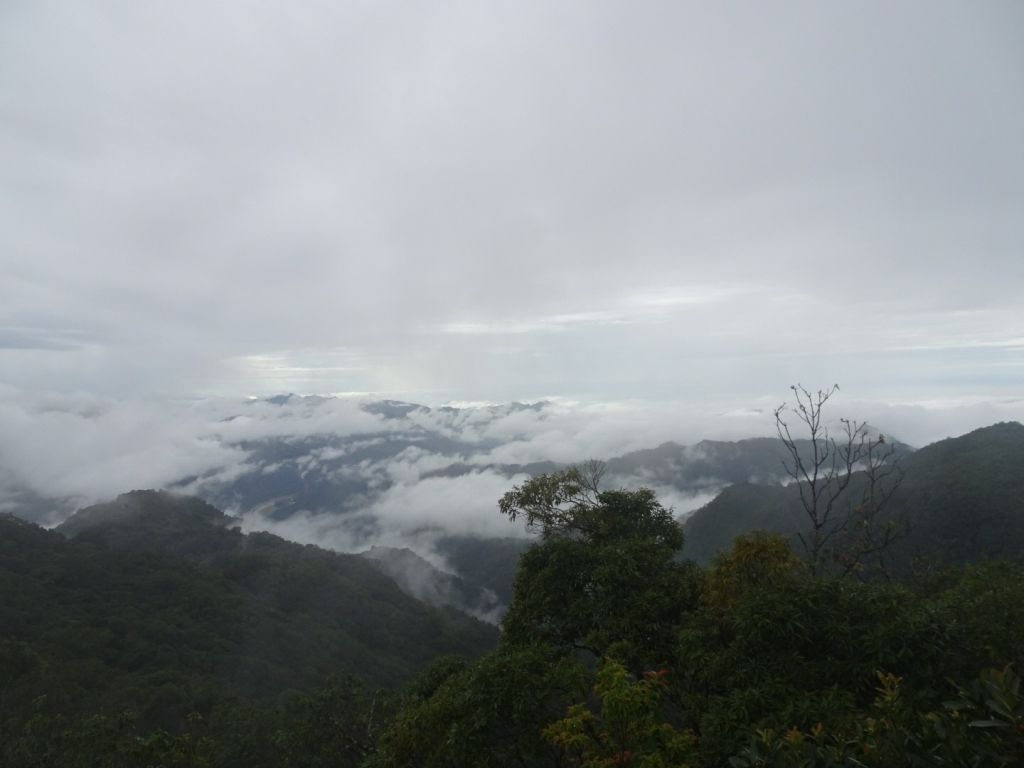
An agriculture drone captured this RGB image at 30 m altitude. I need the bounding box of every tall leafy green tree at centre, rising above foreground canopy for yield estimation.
[499,463,697,672]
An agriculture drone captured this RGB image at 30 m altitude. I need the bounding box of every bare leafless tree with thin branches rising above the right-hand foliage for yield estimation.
[775,384,903,575]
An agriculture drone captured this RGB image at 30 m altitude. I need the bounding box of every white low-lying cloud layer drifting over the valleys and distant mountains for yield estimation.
[0,388,1024,532]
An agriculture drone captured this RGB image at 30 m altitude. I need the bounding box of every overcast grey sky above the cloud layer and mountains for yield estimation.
[0,0,1024,415]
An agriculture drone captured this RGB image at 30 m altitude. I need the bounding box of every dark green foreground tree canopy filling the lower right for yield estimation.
[370,473,1024,768]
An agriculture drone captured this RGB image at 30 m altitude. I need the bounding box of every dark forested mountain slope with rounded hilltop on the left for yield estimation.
[0,492,497,757]
